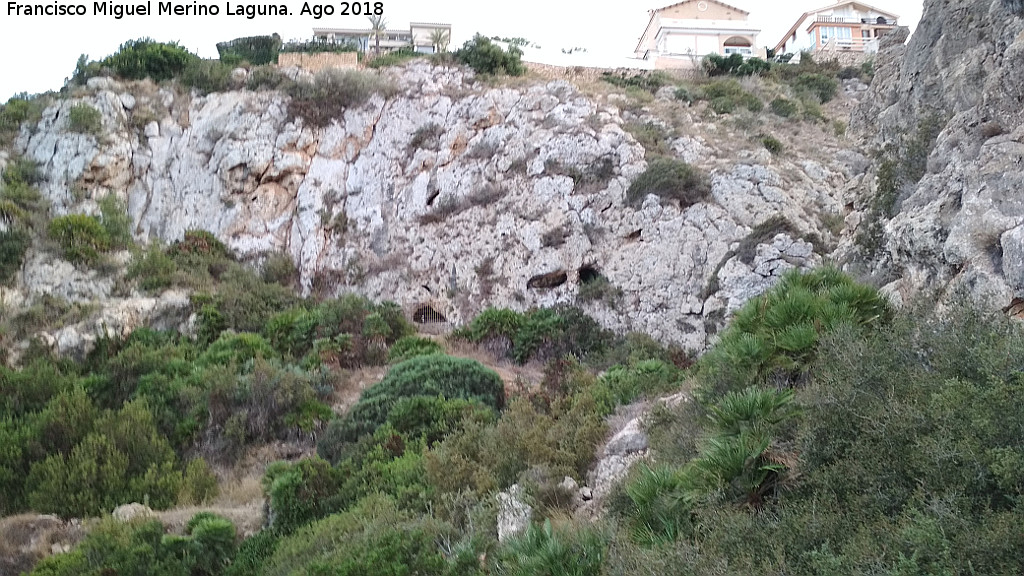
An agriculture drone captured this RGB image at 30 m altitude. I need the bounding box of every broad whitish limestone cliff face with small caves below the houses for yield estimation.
[17,61,856,349]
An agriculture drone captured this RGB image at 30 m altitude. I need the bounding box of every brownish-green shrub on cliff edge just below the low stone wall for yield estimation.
[288,70,392,127]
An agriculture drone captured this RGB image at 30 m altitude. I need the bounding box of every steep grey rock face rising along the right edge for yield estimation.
[851,0,1024,308]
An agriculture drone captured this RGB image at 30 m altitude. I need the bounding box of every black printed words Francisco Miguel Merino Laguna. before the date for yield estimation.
[7,0,296,19]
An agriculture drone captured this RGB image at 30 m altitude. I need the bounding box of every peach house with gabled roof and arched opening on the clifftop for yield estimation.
[635,0,761,69]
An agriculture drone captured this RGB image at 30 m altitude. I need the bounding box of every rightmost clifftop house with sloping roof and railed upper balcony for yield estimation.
[775,1,899,55]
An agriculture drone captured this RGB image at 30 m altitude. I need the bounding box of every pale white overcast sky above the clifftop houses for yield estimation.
[0,0,922,101]
